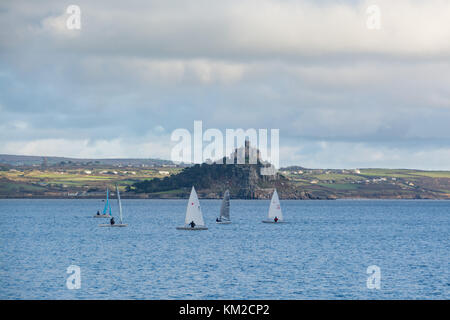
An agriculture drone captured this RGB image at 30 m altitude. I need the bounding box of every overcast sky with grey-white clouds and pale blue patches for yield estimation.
[0,0,450,170]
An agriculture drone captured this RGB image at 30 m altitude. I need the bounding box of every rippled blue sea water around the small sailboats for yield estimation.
[0,200,450,299]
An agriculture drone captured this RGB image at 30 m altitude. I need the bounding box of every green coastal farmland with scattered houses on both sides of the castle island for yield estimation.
[0,166,450,199]
